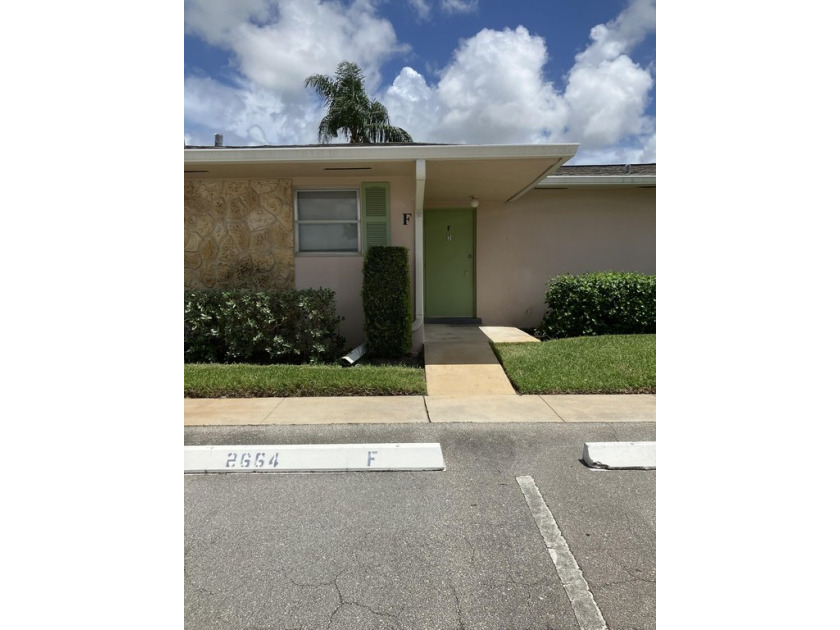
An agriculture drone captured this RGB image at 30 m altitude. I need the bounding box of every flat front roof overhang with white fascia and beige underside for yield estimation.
[184,144,578,207]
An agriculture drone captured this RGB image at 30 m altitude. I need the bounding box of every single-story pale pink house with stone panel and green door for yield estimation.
[184,143,656,349]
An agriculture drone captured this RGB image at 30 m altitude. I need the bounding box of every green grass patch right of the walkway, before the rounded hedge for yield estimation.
[494,335,656,394]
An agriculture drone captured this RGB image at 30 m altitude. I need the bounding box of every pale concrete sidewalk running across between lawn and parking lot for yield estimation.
[184,394,656,426]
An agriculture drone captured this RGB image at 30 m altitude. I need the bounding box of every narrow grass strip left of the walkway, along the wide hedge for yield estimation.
[184,363,426,398]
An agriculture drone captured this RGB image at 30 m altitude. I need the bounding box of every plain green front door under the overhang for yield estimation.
[423,208,475,317]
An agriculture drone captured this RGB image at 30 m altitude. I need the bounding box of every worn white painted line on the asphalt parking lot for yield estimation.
[516,476,607,630]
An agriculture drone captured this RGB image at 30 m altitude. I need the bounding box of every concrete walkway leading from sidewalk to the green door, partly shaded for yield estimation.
[423,324,539,396]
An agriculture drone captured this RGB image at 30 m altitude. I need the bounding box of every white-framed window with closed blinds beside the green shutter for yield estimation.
[295,190,360,254]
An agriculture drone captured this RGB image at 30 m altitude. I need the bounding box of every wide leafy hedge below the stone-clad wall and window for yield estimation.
[184,289,344,364]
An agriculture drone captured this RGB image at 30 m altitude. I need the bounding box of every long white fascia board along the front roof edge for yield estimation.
[184,144,578,164]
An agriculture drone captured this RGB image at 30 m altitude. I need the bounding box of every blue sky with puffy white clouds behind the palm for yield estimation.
[184,0,656,164]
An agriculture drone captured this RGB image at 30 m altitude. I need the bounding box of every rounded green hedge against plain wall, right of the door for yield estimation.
[537,271,656,339]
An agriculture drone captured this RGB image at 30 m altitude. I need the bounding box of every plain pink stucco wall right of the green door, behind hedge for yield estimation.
[476,188,656,327]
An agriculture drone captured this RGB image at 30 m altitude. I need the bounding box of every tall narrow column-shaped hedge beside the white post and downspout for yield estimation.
[362,246,411,358]
